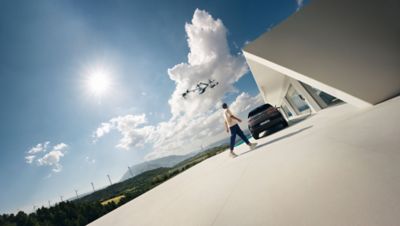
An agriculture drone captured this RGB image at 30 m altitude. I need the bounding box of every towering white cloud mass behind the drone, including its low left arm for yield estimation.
[94,9,261,159]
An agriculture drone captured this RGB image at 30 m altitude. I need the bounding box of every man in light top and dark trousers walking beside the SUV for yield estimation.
[222,103,257,157]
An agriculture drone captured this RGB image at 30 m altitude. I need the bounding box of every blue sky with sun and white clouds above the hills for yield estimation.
[0,0,304,213]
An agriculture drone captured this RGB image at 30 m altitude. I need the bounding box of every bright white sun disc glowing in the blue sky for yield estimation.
[87,69,111,96]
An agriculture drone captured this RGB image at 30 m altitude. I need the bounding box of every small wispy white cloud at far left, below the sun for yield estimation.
[25,141,68,172]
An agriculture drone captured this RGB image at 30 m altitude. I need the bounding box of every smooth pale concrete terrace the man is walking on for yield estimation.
[90,97,400,226]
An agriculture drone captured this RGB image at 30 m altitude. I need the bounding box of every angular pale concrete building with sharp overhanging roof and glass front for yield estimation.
[243,0,400,118]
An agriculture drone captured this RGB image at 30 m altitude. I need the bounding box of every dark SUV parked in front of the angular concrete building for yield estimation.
[248,104,288,139]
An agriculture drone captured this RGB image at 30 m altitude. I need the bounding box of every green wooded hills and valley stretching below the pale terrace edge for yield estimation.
[0,144,228,226]
